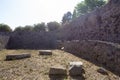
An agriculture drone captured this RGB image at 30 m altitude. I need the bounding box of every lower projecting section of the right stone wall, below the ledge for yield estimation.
[64,40,120,74]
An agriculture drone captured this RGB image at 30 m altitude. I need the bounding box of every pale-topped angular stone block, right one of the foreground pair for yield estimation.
[69,62,85,76]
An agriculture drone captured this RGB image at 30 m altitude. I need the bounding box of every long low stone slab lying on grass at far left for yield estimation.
[6,53,31,60]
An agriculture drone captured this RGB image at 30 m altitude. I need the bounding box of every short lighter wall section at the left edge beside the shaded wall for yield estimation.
[0,35,9,50]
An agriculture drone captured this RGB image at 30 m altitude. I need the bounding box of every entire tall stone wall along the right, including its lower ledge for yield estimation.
[63,0,120,74]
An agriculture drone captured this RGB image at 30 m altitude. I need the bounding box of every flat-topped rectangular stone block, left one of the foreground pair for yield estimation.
[49,65,67,75]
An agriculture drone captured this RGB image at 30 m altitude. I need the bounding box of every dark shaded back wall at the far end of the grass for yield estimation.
[7,31,56,49]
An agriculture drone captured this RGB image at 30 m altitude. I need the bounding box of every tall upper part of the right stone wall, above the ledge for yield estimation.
[63,0,120,43]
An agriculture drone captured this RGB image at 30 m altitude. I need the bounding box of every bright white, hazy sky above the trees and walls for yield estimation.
[0,0,82,29]
